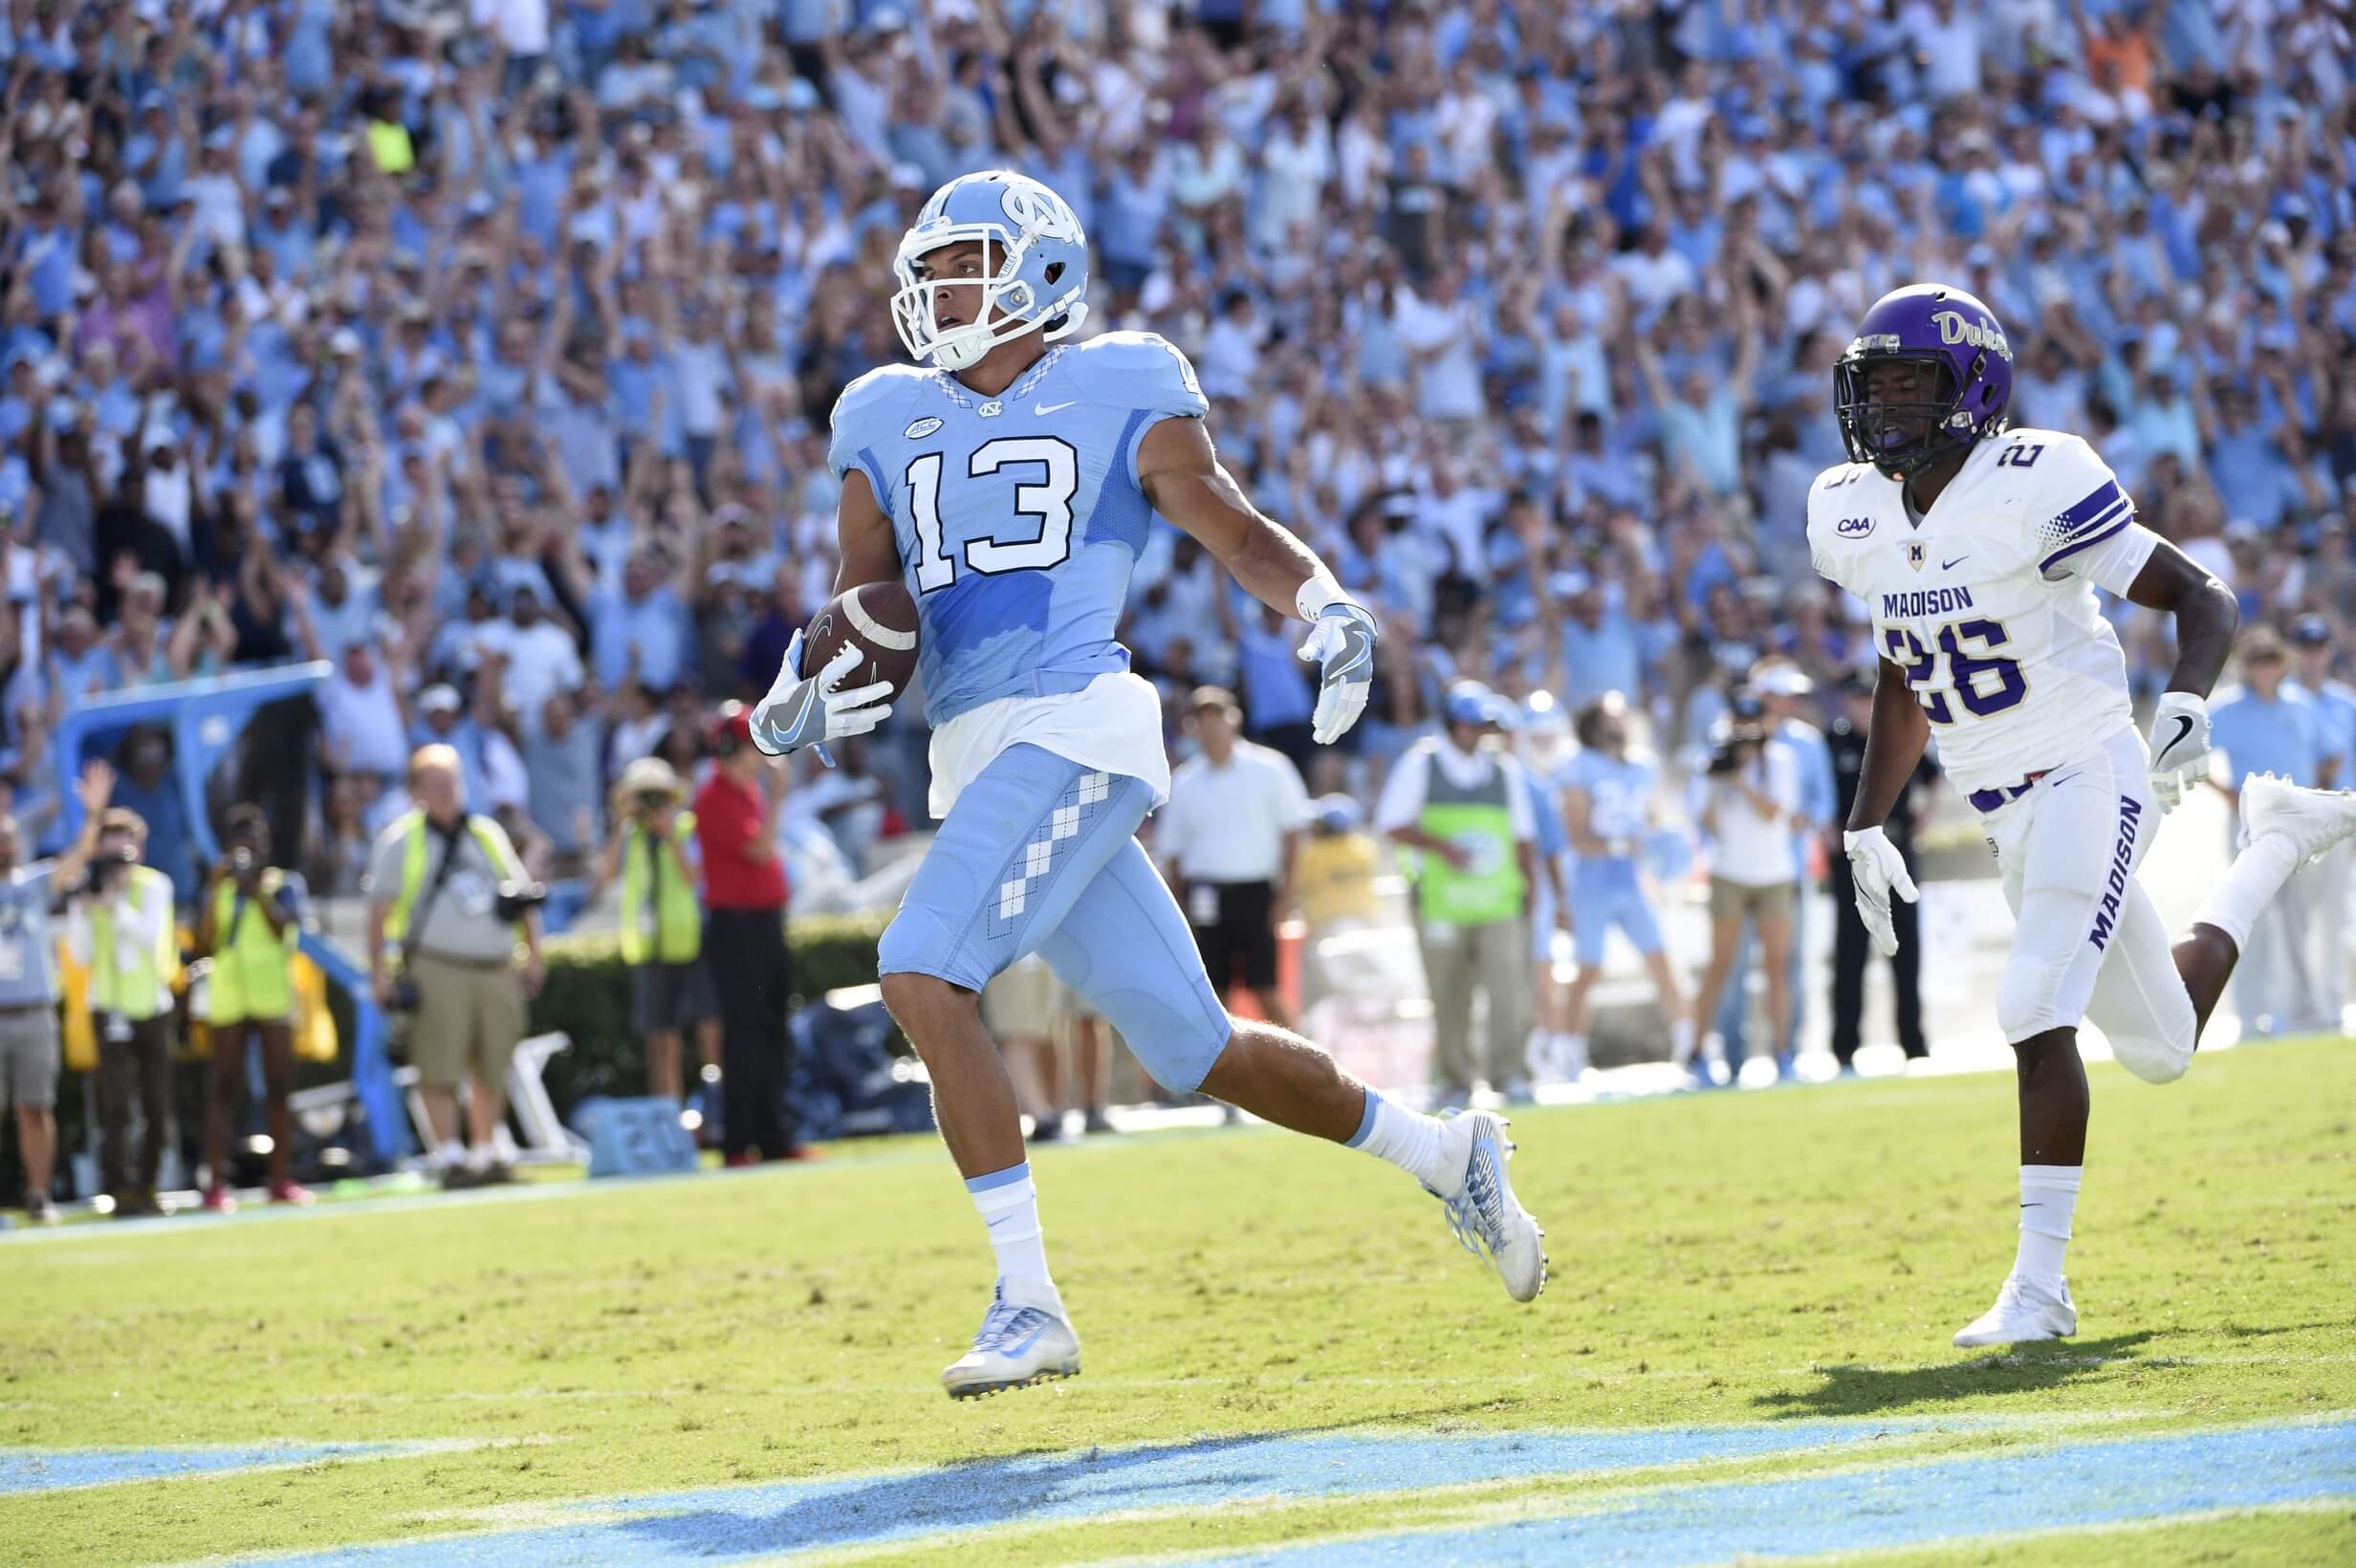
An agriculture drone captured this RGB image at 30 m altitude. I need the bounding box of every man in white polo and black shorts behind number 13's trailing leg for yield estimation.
[1154,686,1310,1029]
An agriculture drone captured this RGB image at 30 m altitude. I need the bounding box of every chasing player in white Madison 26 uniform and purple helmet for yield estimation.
[1807,285,2356,1347]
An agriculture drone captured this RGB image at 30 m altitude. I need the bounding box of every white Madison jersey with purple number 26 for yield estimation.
[1807,431,2158,791]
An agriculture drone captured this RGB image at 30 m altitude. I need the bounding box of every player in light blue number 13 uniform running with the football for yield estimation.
[753,169,1545,1396]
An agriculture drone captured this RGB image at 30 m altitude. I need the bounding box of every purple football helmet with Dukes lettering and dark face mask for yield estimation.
[1833,282,2012,480]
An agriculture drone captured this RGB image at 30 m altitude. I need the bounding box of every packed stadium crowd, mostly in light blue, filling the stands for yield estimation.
[0,0,2356,1134]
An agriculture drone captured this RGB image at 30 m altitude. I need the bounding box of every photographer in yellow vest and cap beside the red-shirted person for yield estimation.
[591,755,719,1100]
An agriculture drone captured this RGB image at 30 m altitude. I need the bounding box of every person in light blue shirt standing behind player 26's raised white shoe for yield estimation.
[2210,624,2335,1035]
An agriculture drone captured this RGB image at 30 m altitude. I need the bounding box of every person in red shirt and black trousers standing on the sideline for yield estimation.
[695,702,811,1165]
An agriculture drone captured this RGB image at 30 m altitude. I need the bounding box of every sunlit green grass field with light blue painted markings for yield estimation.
[0,1043,2356,1566]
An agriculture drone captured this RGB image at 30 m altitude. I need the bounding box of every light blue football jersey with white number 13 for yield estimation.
[827,332,1209,730]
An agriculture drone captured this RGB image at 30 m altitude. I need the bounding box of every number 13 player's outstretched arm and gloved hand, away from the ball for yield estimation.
[1138,417,1378,744]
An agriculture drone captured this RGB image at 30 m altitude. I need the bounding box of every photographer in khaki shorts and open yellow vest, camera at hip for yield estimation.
[365,747,547,1189]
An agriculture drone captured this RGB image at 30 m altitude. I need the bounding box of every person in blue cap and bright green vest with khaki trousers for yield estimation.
[1374,681,1538,1104]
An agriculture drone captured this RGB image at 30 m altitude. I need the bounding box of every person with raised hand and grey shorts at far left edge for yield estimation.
[0,763,116,1224]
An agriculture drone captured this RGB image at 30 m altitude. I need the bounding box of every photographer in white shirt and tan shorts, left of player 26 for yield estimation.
[1694,690,1800,1083]
